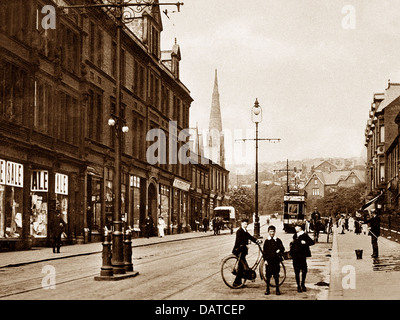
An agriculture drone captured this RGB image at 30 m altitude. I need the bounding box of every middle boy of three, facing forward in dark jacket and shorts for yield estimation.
[263,226,285,295]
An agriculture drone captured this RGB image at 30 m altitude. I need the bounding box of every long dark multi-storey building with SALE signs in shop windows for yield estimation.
[0,0,197,250]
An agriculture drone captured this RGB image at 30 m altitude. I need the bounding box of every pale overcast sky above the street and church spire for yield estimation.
[160,0,400,168]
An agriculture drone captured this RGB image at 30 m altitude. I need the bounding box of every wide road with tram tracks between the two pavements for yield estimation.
[0,220,331,300]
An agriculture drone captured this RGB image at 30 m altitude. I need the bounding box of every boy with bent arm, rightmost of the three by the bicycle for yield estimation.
[290,223,315,292]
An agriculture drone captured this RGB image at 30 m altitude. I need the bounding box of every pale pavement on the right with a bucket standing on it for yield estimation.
[328,229,400,300]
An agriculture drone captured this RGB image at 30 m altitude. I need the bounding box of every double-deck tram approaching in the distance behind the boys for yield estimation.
[283,190,307,232]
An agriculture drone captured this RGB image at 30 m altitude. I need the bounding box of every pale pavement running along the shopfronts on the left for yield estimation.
[0,230,230,269]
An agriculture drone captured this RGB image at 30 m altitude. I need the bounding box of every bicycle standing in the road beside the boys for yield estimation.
[221,243,286,289]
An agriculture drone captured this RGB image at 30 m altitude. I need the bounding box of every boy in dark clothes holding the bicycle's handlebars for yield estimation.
[232,219,257,286]
